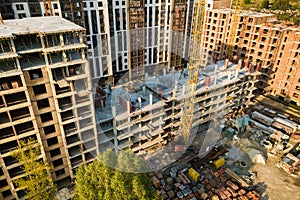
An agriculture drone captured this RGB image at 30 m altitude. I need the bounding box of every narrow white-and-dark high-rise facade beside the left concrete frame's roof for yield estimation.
[83,0,113,83]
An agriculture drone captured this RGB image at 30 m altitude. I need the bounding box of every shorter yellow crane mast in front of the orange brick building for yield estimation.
[228,0,243,60]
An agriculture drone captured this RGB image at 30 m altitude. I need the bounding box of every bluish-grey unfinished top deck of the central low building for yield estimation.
[96,61,256,122]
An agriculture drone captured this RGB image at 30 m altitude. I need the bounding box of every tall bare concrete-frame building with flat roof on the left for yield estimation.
[0,17,98,199]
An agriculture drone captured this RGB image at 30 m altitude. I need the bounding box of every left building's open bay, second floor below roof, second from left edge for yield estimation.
[19,52,46,69]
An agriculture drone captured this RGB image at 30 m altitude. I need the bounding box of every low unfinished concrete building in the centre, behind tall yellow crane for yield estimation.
[96,60,260,157]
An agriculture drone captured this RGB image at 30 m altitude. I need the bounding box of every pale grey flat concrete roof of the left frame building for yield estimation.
[0,16,85,38]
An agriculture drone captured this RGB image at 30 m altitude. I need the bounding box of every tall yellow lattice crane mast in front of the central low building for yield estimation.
[181,0,206,142]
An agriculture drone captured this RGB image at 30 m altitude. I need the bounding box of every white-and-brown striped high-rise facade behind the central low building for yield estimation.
[108,0,193,79]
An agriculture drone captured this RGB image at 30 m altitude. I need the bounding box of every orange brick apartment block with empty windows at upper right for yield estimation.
[198,9,300,105]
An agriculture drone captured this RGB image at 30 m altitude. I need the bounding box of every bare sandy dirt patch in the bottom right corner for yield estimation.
[252,156,300,200]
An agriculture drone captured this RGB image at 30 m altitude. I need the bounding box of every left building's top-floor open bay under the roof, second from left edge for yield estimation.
[14,34,42,53]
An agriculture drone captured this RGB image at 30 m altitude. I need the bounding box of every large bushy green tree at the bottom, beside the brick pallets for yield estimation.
[75,150,159,200]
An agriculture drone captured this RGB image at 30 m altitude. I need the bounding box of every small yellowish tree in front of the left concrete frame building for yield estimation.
[12,138,57,200]
